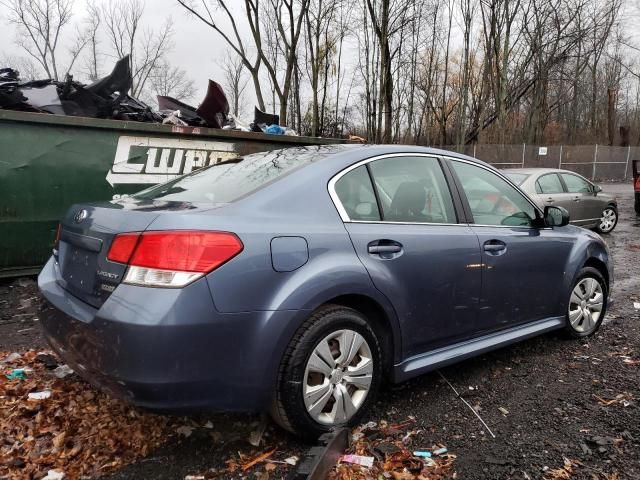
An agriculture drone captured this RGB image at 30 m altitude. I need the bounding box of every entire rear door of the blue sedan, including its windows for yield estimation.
[330,154,480,356]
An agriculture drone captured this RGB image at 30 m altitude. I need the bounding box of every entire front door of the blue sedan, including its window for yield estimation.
[451,159,572,331]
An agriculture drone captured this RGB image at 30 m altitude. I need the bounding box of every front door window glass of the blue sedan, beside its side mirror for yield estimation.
[451,161,536,227]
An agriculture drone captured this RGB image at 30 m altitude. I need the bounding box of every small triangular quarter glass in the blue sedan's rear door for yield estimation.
[335,165,380,222]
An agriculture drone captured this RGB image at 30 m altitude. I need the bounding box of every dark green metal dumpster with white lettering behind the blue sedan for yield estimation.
[0,110,342,277]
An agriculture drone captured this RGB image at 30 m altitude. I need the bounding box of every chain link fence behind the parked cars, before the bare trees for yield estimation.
[442,144,640,181]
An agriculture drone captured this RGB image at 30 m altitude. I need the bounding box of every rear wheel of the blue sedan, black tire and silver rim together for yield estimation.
[271,305,382,439]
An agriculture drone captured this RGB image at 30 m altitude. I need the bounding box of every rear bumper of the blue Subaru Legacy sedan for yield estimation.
[38,259,307,411]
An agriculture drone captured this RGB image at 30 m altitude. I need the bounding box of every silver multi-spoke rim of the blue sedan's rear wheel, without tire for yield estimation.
[302,330,374,425]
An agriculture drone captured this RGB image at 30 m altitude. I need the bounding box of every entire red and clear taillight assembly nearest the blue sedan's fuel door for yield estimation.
[107,230,244,287]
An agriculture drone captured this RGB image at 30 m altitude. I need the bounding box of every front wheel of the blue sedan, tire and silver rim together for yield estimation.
[565,267,608,338]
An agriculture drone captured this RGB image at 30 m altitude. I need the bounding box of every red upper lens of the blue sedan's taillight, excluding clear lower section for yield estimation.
[129,231,243,273]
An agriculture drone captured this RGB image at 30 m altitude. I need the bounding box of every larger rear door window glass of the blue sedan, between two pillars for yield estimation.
[369,156,457,223]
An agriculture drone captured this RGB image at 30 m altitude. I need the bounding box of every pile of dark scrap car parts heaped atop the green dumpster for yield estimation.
[0,56,295,135]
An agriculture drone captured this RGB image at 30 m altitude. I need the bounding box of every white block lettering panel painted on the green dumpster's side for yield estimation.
[107,136,238,186]
